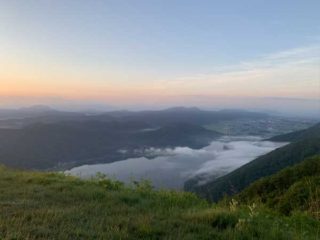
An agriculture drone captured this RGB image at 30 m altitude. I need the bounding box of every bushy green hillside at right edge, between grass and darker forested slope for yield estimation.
[237,155,320,219]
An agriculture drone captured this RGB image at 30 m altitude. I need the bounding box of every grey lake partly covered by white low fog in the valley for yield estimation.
[66,137,286,189]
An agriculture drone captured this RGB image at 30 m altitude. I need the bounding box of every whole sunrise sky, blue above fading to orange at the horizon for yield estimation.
[0,0,320,114]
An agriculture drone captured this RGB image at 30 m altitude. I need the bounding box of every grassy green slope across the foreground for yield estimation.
[0,167,320,240]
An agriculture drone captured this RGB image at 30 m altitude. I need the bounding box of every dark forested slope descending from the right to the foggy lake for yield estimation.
[185,124,320,201]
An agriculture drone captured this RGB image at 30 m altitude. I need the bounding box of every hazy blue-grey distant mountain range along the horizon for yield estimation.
[0,105,268,128]
